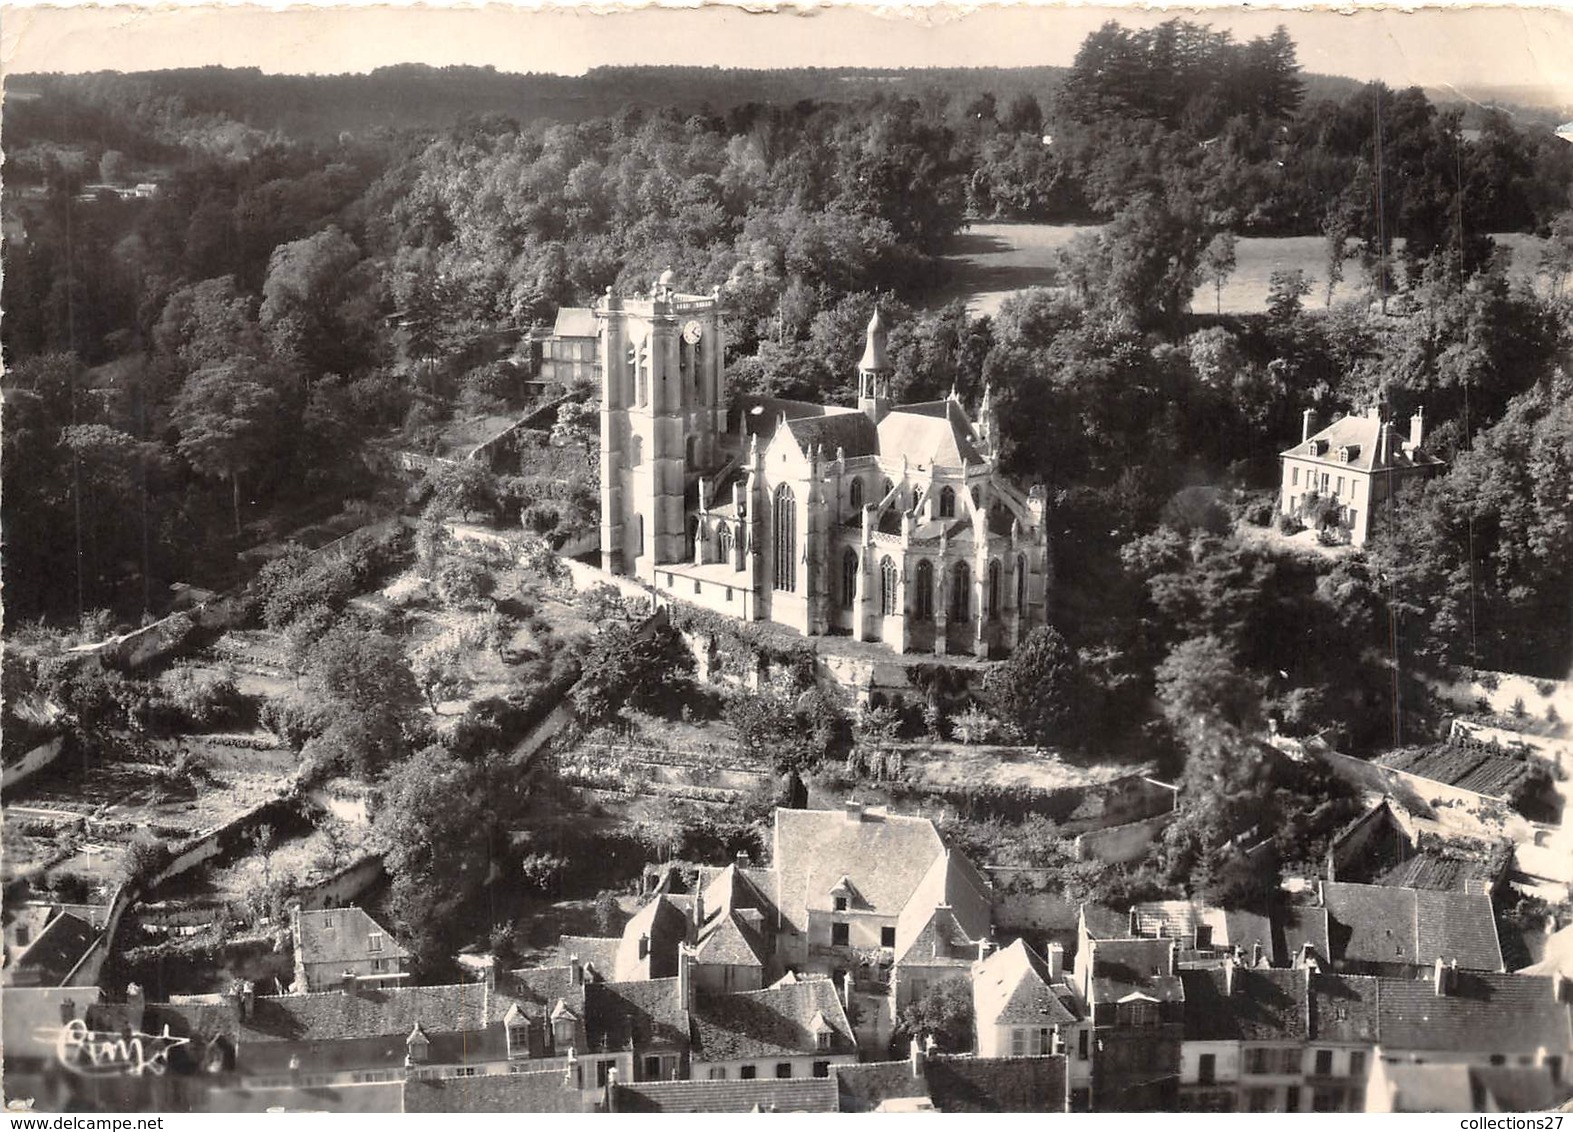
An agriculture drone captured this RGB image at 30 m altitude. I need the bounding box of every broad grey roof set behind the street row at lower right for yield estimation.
[1323,880,1504,972]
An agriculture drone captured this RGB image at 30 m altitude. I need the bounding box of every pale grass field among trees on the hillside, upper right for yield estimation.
[939,223,1543,314]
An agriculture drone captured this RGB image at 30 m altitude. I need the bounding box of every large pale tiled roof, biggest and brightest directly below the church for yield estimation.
[775,810,944,932]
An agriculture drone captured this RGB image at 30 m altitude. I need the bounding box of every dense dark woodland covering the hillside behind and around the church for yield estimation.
[3,20,1573,710]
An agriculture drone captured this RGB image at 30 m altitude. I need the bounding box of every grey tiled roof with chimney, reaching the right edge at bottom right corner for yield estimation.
[1376,970,1573,1053]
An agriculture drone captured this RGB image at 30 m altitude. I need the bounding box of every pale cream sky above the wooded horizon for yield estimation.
[0,0,1573,112]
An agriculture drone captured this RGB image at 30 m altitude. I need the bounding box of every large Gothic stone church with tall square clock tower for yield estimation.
[591,272,1049,657]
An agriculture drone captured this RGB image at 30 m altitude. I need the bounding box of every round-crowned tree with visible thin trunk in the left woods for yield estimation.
[173,362,278,546]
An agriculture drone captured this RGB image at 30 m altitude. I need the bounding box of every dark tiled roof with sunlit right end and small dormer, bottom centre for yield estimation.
[694,979,857,1061]
